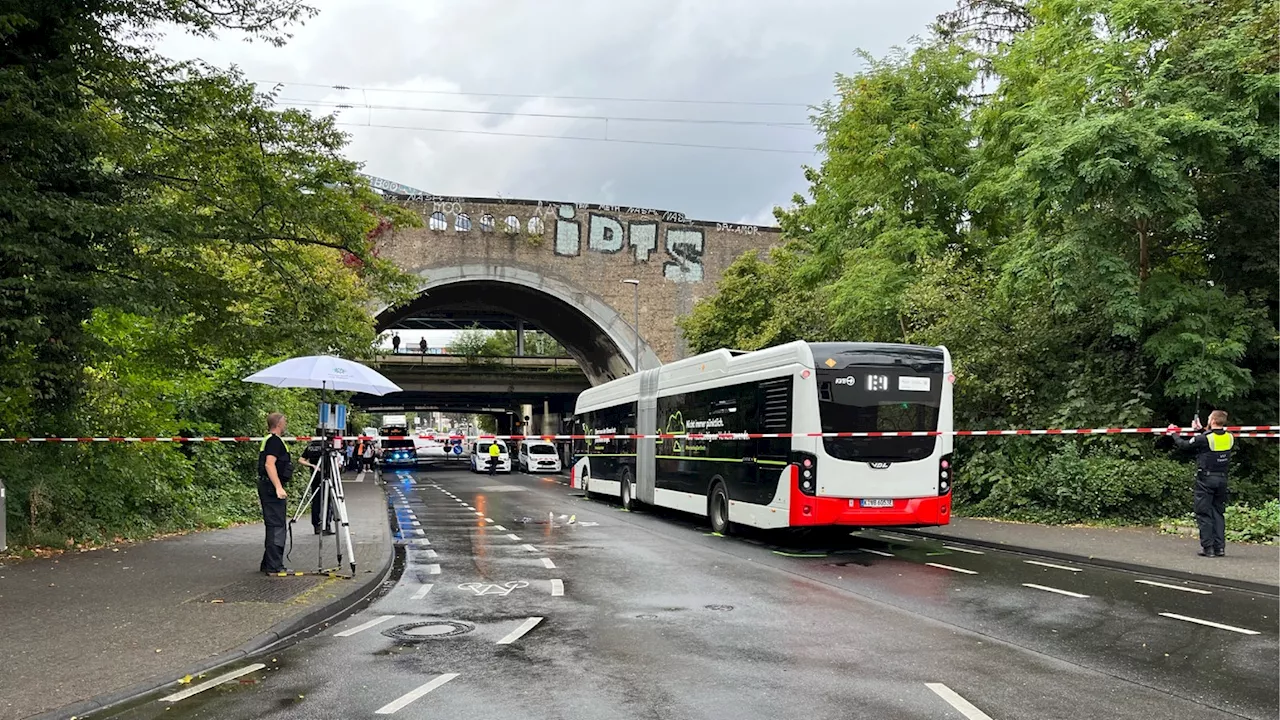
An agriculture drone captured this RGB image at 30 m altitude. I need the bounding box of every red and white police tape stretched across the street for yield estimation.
[0,425,1280,445]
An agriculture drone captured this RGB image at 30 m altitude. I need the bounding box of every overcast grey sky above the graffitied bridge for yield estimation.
[159,0,955,224]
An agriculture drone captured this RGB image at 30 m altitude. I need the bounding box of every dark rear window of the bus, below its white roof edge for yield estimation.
[817,366,942,462]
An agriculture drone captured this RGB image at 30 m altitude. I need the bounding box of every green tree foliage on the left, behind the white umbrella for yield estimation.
[0,0,413,548]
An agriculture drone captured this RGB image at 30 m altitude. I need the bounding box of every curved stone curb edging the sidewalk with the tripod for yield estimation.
[37,483,396,720]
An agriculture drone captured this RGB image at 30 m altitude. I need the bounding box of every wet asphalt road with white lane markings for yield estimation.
[94,461,1280,720]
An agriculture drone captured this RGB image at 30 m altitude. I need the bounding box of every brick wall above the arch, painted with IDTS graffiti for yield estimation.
[378,196,778,363]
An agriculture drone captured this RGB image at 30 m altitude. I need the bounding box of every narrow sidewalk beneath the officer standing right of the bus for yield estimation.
[902,518,1280,594]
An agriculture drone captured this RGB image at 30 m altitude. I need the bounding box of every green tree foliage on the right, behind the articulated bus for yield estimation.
[681,0,1280,520]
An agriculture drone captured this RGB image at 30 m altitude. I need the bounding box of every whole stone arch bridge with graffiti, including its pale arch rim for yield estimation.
[375,183,778,384]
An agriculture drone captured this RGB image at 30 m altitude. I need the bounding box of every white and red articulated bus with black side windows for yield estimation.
[571,342,955,533]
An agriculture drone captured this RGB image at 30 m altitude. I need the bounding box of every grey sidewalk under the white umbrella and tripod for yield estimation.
[0,473,393,720]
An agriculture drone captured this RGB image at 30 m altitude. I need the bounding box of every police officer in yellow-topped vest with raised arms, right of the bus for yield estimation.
[1167,410,1235,557]
